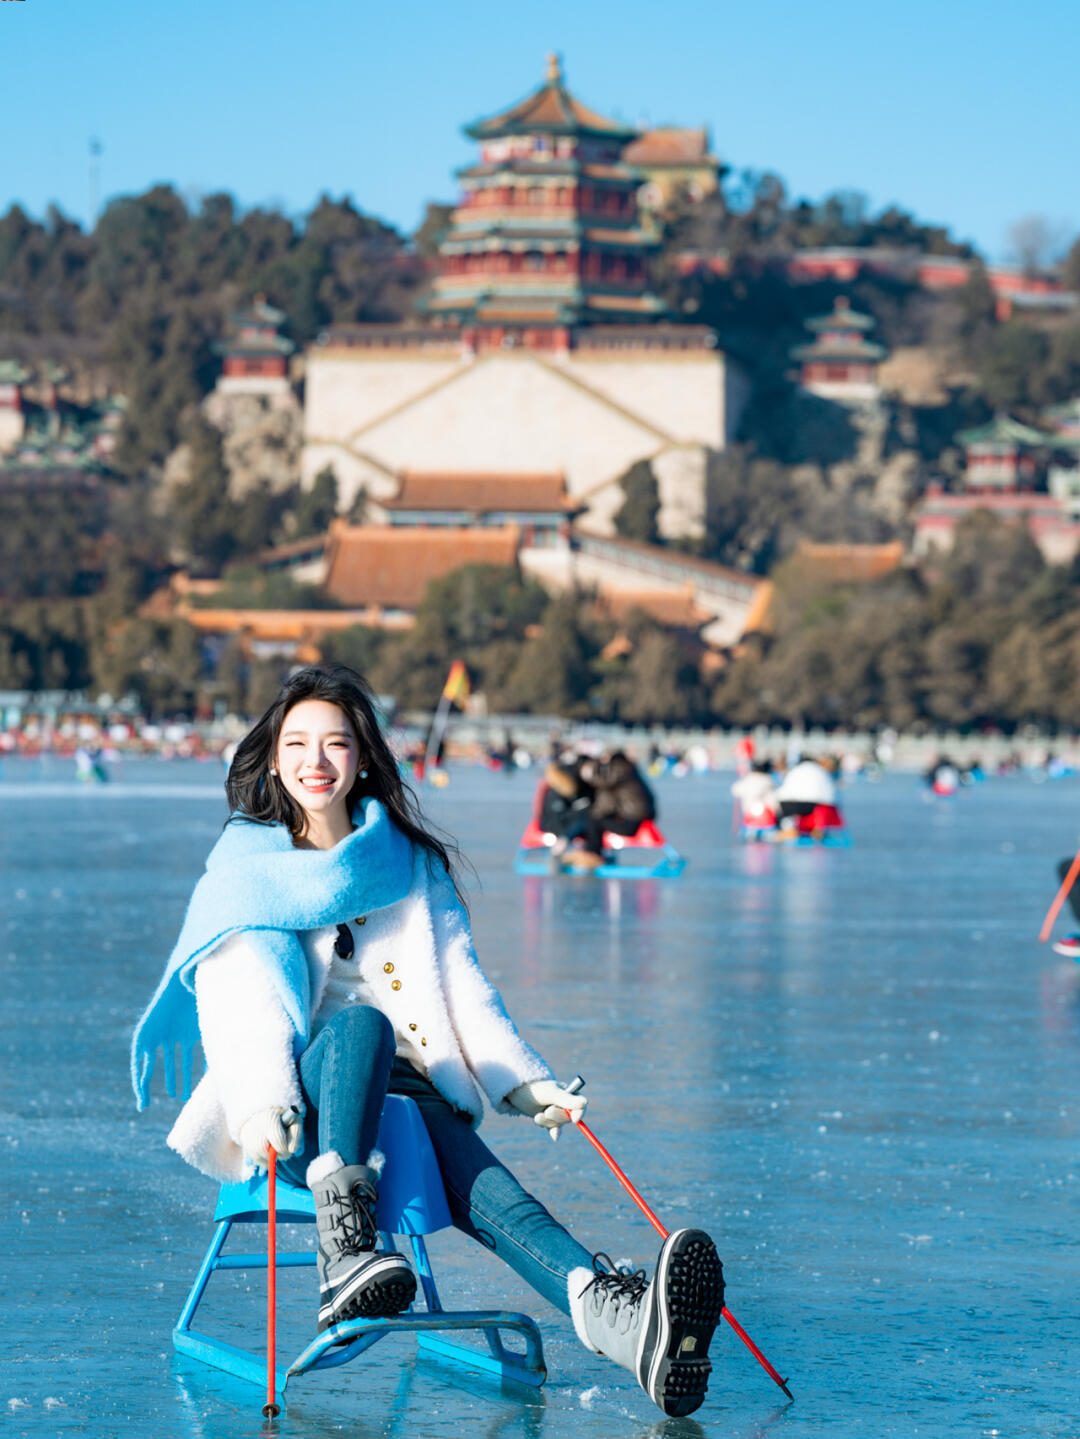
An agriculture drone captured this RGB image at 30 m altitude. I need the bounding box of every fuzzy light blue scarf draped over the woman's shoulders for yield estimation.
[131,799,413,1109]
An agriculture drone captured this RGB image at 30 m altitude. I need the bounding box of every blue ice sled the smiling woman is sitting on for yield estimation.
[173,1095,546,1394]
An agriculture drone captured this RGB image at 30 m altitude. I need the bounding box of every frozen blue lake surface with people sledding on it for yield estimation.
[0,761,1080,1439]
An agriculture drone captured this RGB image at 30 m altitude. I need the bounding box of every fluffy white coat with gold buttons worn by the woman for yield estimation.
[168,848,552,1180]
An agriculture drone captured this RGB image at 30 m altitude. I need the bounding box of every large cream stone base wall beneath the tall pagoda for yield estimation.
[302,347,733,537]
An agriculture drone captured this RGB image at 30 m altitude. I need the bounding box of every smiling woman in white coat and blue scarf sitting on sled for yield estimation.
[132,666,723,1415]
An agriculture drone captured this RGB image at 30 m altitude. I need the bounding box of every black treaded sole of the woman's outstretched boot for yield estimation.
[637,1229,723,1417]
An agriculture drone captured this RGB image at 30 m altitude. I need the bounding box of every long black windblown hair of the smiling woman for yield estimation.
[224,665,460,888]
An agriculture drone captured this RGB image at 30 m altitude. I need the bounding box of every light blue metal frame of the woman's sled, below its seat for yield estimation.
[173,1116,546,1396]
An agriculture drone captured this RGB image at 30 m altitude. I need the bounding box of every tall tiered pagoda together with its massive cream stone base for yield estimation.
[302,58,748,538]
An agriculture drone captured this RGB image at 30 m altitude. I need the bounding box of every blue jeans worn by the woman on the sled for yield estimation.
[270,1004,592,1314]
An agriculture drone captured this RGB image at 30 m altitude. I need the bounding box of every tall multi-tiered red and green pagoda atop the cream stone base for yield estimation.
[424,55,663,350]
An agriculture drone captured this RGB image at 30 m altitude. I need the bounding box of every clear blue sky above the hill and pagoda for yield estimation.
[0,0,1080,259]
